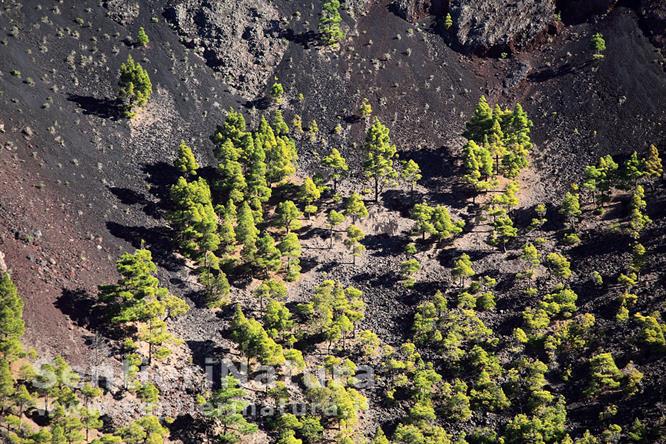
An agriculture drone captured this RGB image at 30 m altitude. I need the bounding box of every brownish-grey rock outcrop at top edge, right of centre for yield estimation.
[450,0,555,53]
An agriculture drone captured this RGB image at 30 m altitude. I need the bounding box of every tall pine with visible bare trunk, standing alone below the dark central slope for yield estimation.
[364,118,398,202]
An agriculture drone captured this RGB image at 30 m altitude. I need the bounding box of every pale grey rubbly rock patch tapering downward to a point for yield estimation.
[165,0,287,98]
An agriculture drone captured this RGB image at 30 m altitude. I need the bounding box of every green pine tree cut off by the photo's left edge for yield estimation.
[0,271,25,361]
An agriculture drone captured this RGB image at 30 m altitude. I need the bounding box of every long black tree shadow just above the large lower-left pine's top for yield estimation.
[106,221,185,272]
